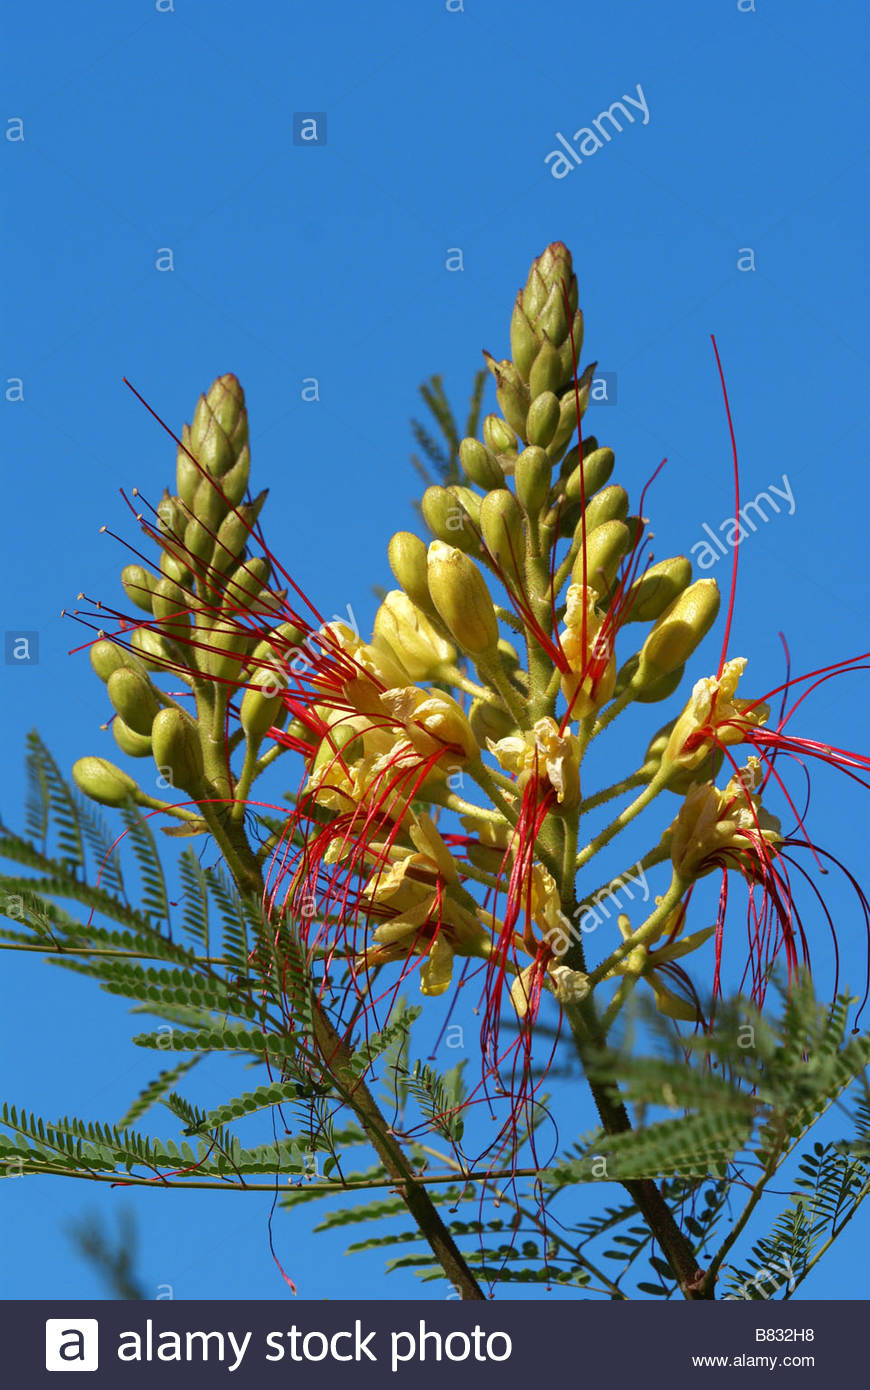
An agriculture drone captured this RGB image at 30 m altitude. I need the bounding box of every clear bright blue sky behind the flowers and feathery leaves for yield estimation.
[0,0,870,1298]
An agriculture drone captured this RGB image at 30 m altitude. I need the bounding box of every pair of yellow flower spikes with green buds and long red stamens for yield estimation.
[75,243,869,1139]
